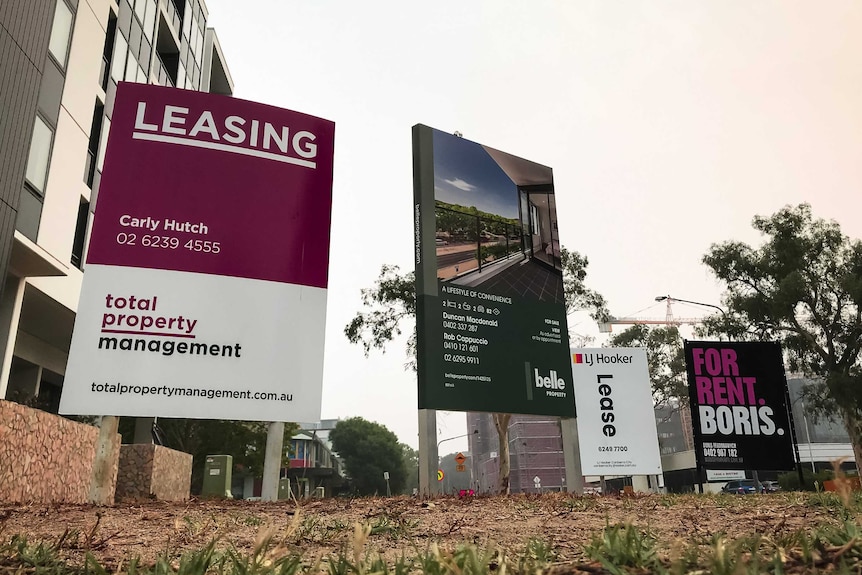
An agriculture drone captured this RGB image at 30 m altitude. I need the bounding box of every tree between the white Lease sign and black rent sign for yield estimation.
[610,324,688,406]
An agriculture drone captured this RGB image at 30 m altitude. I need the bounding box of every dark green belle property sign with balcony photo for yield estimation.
[413,125,575,417]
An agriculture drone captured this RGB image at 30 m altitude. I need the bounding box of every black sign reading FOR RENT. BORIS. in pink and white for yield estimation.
[685,341,795,469]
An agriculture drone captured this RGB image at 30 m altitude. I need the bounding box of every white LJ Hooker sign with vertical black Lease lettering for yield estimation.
[572,348,662,475]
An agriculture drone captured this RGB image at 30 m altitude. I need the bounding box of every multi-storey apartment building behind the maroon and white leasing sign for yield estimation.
[0,0,233,412]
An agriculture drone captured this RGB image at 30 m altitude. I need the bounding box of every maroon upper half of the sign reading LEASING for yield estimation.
[87,83,335,288]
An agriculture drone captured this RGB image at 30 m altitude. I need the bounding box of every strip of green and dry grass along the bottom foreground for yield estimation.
[8,522,862,575]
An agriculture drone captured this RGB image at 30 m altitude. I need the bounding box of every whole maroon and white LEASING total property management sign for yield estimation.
[60,84,334,421]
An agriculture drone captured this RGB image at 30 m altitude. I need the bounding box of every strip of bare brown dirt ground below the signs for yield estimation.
[0,493,852,565]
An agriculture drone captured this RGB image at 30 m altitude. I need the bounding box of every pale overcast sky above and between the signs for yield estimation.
[206,0,862,453]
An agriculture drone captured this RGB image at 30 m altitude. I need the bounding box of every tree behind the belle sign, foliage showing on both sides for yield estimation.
[344,247,610,493]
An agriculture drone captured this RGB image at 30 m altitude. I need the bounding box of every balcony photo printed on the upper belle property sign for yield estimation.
[434,136,565,304]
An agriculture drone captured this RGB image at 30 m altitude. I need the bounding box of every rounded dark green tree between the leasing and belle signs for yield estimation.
[329,417,407,495]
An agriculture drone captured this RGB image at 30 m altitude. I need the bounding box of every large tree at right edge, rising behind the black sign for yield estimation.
[703,204,862,468]
